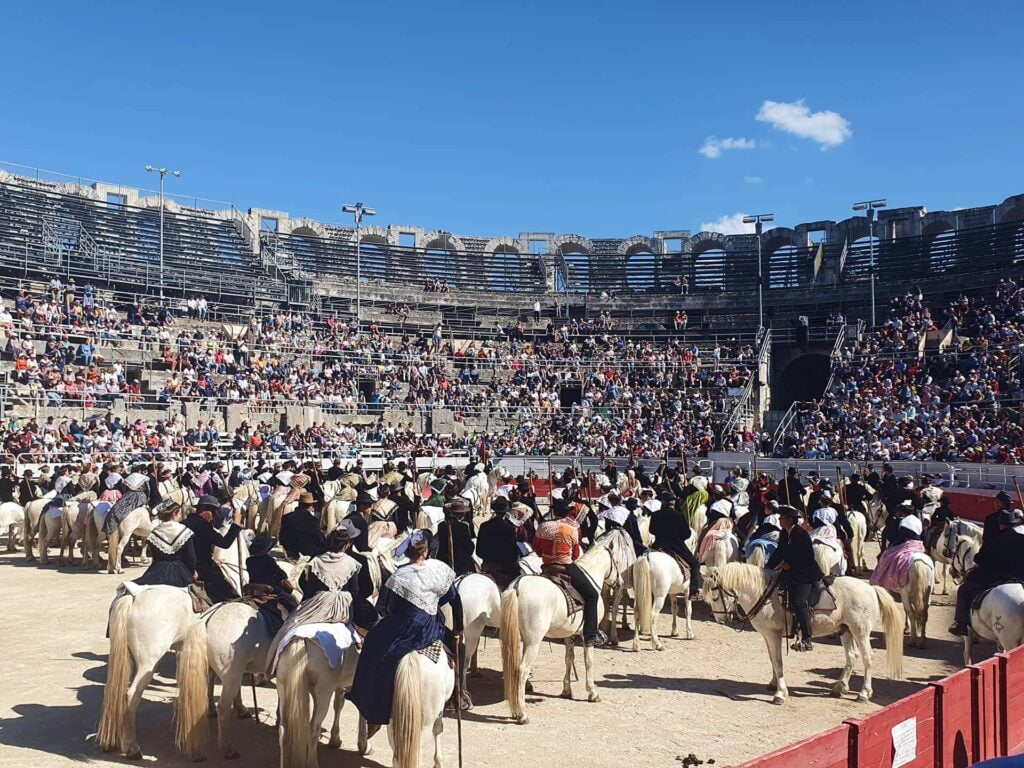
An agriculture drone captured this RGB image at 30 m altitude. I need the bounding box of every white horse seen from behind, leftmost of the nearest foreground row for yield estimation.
[97,586,196,760]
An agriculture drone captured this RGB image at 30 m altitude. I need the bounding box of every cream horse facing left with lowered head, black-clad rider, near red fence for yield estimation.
[703,563,903,705]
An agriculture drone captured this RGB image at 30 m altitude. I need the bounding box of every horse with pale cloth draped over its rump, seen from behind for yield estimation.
[278,637,358,768]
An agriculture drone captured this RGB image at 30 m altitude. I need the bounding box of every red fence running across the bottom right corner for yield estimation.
[737,647,1024,768]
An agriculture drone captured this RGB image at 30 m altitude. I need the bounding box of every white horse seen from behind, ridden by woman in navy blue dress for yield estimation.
[358,651,455,768]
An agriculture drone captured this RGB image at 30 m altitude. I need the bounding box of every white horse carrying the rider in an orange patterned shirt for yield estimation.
[500,529,633,725]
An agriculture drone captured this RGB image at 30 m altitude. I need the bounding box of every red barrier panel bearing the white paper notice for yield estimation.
[846,679,937,768]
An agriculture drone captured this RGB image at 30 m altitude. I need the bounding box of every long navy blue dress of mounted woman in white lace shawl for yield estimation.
[348,565,462,725]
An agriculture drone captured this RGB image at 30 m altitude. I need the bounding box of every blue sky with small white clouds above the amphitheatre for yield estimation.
[0,0,1024,237]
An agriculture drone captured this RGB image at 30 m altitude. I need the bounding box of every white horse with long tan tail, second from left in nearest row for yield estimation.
[175,602,273,760]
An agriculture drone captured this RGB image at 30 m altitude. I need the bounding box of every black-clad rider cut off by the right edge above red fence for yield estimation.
[949,509,1024,637]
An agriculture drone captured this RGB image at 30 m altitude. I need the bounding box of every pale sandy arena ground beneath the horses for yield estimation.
[0,540,992,768]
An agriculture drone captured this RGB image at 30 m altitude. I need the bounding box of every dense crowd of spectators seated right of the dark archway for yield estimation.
[778,279,1024,464]
